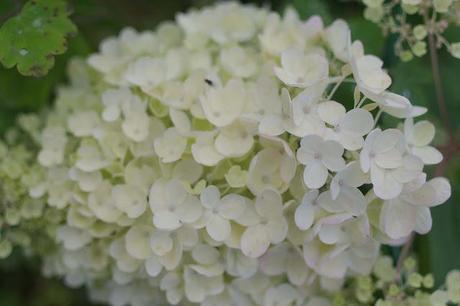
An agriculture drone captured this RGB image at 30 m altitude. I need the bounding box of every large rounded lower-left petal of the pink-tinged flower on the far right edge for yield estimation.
[380,200,417,239]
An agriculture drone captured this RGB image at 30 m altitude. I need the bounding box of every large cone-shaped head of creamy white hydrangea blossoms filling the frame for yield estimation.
[2,2,450,306]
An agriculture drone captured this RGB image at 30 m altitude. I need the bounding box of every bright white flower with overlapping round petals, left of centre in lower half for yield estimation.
[149,180,202,230]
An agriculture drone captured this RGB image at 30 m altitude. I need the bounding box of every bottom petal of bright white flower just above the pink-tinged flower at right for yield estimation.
[371,165,403,200]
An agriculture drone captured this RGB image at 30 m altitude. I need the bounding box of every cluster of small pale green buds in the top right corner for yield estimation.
[363,0,460,61]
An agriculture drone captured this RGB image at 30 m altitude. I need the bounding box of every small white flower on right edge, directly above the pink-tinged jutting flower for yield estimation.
[404,118,442,165]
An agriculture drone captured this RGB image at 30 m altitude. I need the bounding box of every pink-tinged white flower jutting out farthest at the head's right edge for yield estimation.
[380,177,451,240]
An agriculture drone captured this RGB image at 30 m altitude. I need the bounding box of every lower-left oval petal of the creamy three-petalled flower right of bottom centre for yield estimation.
[241,225,270,258]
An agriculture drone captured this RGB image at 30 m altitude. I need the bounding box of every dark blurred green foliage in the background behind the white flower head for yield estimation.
[0,0,460,306]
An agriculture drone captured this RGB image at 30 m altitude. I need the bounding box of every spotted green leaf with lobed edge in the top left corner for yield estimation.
[0,0,77,77]
